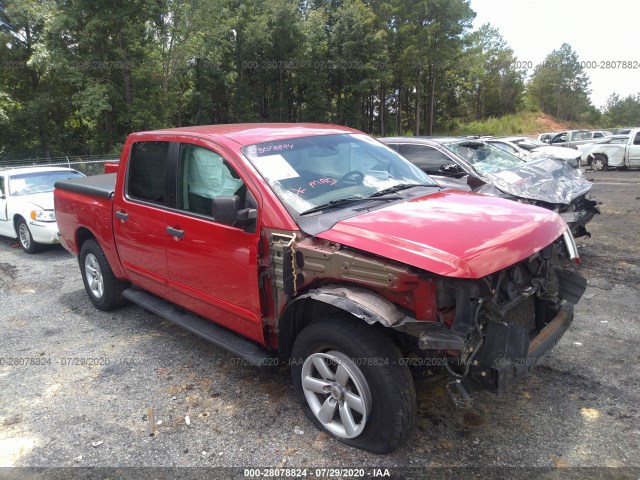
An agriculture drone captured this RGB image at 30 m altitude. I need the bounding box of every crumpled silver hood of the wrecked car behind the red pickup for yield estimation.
[479,156,592,205]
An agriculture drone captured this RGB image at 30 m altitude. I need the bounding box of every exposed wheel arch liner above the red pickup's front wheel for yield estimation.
[278,286,405,358]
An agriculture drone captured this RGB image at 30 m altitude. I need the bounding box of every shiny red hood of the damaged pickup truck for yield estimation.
[316,191,567,278]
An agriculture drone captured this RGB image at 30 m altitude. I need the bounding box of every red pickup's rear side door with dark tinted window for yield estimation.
[113,141,172,300]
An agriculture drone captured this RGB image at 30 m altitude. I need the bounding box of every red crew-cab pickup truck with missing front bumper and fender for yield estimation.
[55,124,586,452]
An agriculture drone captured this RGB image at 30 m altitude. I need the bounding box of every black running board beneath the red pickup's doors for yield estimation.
[122,287,276,367]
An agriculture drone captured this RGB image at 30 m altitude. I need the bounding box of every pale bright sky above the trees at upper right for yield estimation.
[471,0,640,108]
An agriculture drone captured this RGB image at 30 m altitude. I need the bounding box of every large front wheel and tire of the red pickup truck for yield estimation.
[291,316,416,453]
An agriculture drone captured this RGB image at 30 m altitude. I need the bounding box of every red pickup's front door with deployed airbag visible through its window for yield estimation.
[166,143,263,342]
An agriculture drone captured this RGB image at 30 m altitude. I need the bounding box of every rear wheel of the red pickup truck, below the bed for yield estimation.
[78,240,126,311]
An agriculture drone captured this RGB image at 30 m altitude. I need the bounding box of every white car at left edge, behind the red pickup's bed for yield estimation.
[0,167,84,253]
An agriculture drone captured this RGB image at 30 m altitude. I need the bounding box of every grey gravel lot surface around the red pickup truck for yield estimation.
[0,171,640,480]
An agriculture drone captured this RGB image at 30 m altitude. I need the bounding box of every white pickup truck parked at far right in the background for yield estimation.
[578,128,640,170]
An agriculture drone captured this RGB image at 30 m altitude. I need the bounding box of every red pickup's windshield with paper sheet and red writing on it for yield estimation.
[242,134,437,214]
